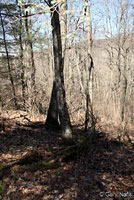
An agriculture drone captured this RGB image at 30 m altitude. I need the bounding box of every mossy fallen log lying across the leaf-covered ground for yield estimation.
[0,134,96,177]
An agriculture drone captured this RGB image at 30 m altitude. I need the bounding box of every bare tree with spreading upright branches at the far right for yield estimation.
[101,0,133,136]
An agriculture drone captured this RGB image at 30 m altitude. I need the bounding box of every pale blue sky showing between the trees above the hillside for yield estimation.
[0,0,134,54]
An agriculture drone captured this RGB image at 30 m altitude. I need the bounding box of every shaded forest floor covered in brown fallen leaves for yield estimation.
[0,112,134,200]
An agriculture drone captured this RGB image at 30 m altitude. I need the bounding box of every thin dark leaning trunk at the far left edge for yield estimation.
[0,12,18,109]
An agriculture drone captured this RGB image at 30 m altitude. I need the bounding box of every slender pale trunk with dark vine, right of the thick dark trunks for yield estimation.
[84,0,94,131]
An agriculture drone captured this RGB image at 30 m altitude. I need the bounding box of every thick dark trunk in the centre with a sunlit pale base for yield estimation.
[51,3,72,139]
